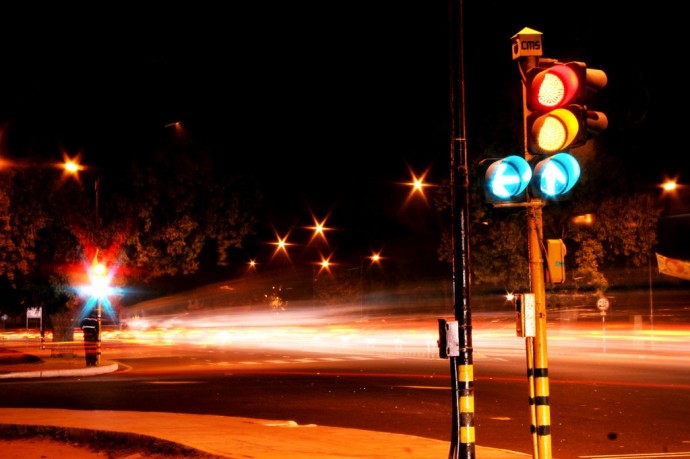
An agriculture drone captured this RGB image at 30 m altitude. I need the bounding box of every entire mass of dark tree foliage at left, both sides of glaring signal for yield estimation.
[0,135,260,339]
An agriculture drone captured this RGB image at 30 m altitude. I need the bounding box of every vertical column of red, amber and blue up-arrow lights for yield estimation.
[524,59,608,200]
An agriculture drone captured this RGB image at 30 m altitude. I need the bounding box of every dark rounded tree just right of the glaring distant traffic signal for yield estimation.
[110,135,260,282]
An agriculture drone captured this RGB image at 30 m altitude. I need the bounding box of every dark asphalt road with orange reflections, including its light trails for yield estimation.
[0,294,690,458]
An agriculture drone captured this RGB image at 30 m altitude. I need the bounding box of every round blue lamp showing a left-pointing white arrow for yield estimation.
[485,155,532,201]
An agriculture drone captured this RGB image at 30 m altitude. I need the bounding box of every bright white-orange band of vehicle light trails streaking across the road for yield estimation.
[84,302,690,366]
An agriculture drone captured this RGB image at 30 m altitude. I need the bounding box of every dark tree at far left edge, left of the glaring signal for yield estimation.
[0,158,86,353]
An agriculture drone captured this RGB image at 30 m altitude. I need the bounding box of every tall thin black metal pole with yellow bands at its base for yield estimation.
[448,0,475,458]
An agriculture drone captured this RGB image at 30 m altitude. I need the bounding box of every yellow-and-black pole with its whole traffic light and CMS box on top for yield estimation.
[508,27,608,459]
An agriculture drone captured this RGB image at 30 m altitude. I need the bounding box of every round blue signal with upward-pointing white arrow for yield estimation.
[534,153,580,199]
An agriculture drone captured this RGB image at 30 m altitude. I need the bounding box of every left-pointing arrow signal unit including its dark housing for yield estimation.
[479,155,532,204]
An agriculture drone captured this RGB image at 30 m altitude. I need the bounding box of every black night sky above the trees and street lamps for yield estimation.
[0,1,690,274]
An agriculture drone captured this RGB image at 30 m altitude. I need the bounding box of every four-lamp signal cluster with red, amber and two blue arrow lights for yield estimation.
[479,58,608,205]
